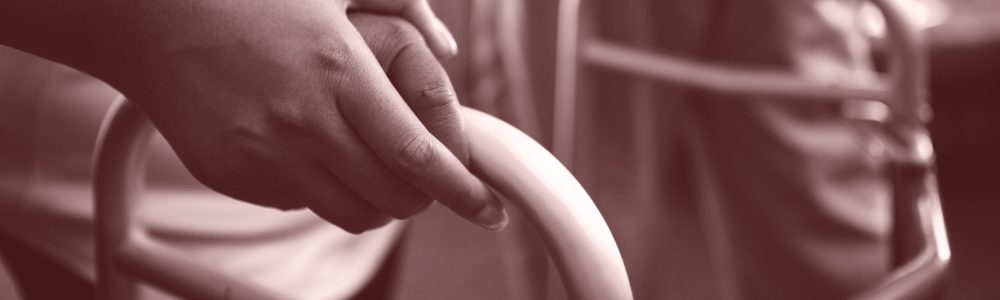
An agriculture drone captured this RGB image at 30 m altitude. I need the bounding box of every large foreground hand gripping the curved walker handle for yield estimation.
[101,0,507,232]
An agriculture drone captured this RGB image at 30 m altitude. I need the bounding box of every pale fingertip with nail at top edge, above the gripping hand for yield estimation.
[402,0,458,58]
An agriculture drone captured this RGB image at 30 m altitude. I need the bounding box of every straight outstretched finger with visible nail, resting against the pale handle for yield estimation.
[337,47,507,230]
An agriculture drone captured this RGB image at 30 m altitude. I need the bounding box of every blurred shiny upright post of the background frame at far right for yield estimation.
[857,0,951,299]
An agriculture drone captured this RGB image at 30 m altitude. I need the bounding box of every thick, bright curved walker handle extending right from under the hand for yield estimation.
[462,109,632,300]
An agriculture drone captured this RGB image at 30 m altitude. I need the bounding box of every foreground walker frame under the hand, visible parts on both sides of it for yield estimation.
[94,99,632,299]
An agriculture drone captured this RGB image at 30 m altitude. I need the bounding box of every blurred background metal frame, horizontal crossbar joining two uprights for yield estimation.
[553,0,951,299]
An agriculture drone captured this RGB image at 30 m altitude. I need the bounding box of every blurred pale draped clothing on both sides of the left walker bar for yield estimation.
[0,48,404,299]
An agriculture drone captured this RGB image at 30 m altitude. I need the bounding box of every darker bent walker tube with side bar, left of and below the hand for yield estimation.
[94,98,287,300]
